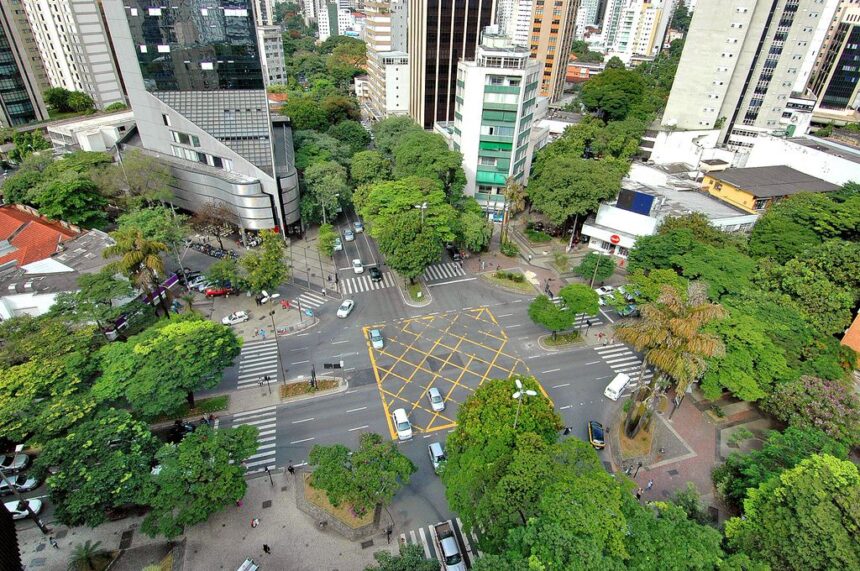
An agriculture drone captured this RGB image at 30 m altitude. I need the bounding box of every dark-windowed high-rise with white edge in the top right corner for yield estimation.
[809,0,860,111]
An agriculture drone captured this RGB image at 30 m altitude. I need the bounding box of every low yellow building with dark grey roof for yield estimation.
[702,165,839,214]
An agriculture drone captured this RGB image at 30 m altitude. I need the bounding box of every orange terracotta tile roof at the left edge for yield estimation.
[0,206,78,266]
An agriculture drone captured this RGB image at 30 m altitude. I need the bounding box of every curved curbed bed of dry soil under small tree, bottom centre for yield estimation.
[296,472,381,541]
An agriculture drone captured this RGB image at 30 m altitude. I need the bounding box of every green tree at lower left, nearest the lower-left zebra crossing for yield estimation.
[141,426,258,539]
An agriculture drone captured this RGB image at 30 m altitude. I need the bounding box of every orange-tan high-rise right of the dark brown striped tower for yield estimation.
[530,0,579,103]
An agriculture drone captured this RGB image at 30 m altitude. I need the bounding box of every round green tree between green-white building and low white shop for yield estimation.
[529,158,628,229]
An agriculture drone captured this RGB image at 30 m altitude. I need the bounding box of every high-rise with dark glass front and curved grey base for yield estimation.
[104,0,299,232]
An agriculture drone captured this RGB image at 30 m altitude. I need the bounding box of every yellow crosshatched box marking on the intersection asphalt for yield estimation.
[364,308,528,438]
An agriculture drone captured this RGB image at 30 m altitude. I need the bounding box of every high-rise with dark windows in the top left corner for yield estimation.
[0,0,49,127]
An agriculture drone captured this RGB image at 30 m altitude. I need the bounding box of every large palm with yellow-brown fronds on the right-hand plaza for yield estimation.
[615,282,726,438]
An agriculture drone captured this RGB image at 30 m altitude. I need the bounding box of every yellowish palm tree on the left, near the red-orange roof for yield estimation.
[102,228,170,319]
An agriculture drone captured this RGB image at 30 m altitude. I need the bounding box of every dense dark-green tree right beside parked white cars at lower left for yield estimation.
[34,408,158,527]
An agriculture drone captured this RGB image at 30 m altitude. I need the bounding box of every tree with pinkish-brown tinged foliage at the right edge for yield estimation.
[764,376,860,445]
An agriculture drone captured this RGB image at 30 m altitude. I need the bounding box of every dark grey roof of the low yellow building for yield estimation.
[708,165,839,197]
